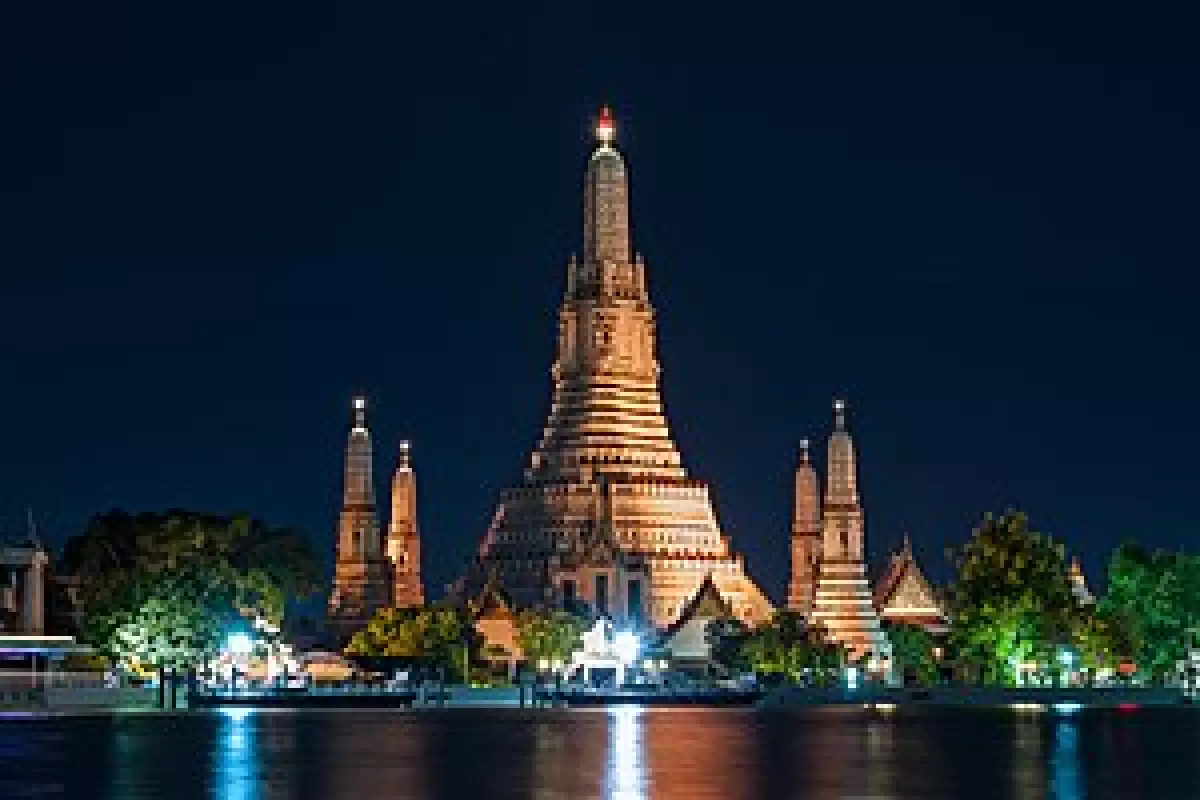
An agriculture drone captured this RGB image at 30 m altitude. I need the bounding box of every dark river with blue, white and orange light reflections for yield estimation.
[0,708,1200,800]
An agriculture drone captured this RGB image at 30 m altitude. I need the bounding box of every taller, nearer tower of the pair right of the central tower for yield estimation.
[811,401,890,660]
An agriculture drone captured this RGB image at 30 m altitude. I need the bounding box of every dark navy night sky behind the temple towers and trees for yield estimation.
[0,2,1200,600]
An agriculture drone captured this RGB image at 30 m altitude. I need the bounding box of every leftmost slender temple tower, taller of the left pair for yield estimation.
[329,397,390,634]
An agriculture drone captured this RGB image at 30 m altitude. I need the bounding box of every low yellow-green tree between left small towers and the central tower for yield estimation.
[346,604,480,680]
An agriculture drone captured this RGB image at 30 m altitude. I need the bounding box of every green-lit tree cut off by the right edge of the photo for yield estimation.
[1099,542,1200,680]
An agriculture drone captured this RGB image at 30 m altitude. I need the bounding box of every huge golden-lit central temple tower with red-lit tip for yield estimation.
[464,109,772,627]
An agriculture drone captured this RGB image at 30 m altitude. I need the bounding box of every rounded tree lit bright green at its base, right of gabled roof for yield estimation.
[949,511,1087,682]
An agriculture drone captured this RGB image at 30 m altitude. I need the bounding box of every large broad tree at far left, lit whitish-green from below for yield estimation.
[62,511,319,669]
